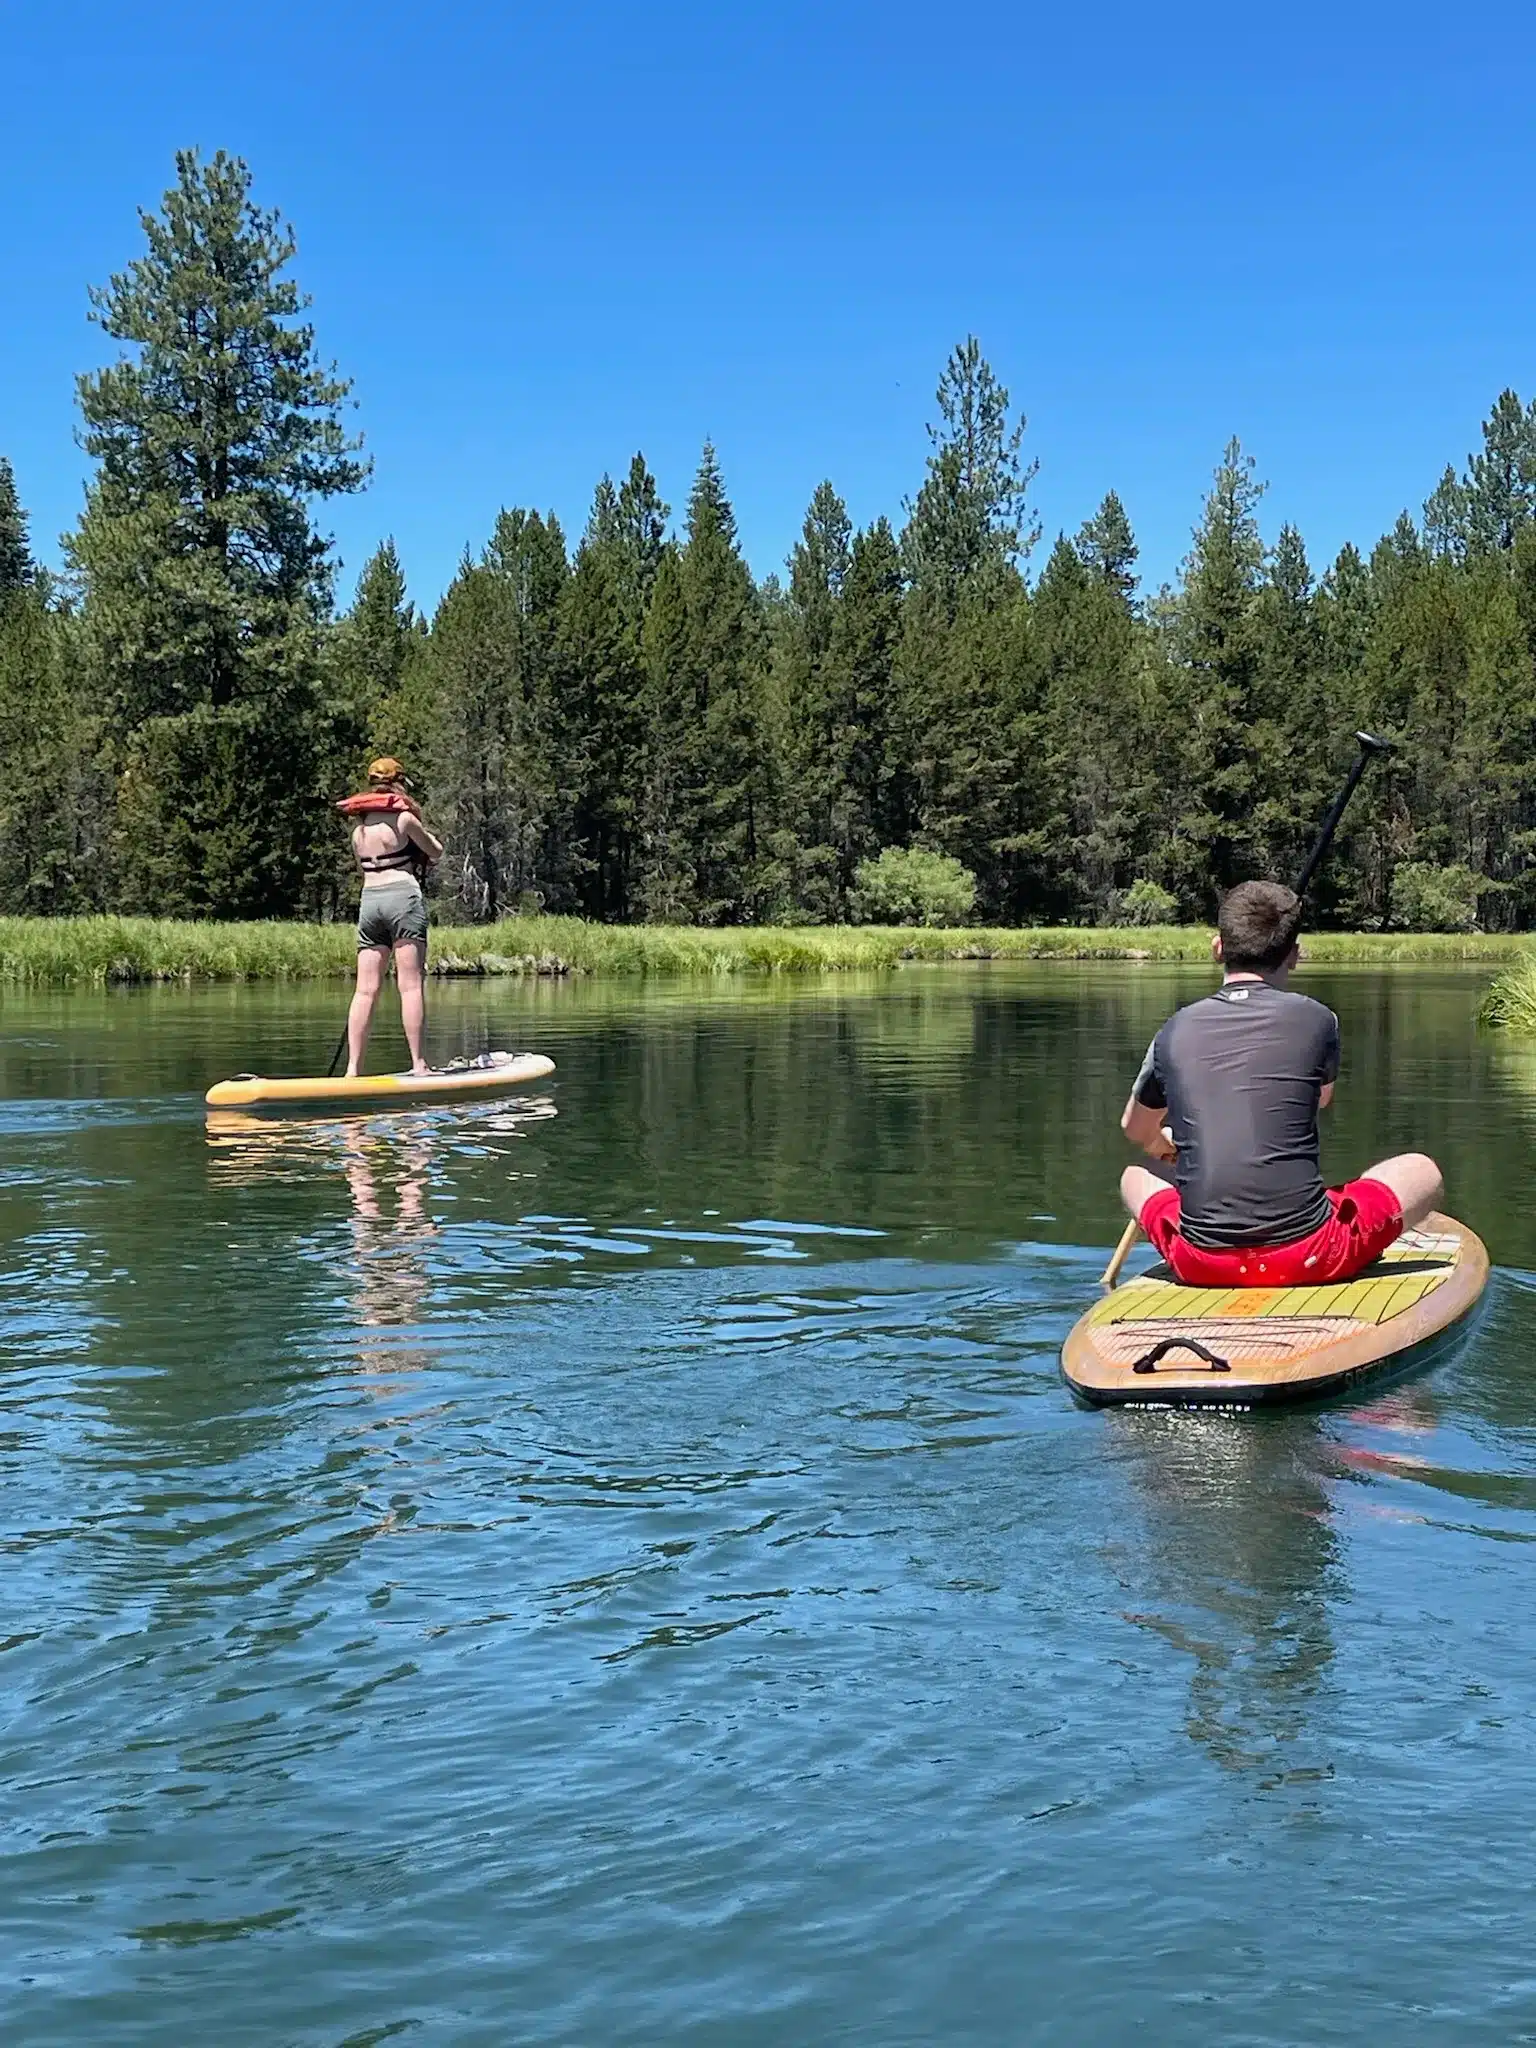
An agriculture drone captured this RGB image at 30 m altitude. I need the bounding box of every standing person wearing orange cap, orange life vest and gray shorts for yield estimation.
[340,756,442,1079]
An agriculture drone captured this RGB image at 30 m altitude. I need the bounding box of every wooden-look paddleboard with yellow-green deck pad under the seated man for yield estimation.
[1061,1214,1489,1409]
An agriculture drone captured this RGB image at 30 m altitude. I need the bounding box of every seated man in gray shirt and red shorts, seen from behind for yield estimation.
[1120,883,1442,1286]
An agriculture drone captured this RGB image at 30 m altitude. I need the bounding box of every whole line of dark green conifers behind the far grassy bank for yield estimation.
[0,152,1536,930]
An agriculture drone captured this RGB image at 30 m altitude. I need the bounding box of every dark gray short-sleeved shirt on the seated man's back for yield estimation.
[1137,981,1339,1251]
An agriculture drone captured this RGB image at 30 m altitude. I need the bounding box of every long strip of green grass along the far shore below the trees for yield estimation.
[0,918,1536,987]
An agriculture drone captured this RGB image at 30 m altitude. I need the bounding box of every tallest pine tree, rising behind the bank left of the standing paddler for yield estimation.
[70,152,367,915]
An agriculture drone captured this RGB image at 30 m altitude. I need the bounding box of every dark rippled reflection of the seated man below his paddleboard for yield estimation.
[1116,1415,1341,1776]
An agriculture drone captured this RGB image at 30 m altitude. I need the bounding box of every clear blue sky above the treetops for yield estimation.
[0,0,1536,604]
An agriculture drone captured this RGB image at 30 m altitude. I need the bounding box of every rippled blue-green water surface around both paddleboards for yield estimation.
[0,965,1536,2048]
